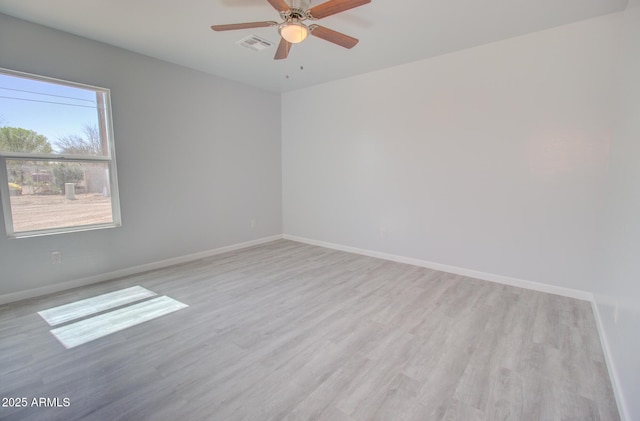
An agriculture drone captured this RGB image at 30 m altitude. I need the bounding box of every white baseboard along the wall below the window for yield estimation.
[0,234,283,305]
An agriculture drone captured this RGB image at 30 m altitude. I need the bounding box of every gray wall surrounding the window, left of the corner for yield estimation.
[0,15,282,296]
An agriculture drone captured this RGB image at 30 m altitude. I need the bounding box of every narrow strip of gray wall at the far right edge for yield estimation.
[594,2,640,420]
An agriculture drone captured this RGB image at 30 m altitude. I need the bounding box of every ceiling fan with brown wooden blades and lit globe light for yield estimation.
[211,0,371,60]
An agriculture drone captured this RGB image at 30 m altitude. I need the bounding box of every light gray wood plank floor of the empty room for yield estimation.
[0,240,619,421]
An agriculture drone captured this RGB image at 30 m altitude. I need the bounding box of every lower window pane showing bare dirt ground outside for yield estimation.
[6,159,114,233]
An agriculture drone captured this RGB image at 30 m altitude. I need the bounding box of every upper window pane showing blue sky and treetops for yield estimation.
[0,73,109,156]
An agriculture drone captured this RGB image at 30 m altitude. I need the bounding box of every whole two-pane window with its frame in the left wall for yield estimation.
[0,69,120,237]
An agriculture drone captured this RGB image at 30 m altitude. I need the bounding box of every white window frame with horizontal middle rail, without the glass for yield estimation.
[0,67,122,238]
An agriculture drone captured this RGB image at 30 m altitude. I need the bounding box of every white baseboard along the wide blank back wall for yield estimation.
[282,234,593,302]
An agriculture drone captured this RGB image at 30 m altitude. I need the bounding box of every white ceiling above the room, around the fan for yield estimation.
[0,0,628,92]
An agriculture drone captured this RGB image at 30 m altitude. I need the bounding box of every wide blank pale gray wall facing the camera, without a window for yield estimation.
[282,15,620,291]
